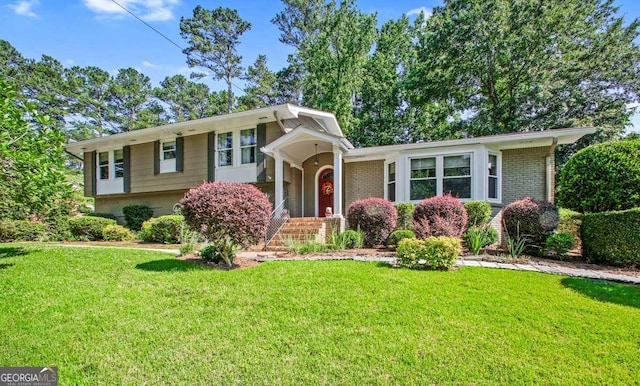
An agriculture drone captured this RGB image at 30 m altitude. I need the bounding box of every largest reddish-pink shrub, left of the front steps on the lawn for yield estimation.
[180,181,271,247]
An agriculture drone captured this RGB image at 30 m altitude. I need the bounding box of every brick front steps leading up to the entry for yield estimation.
[266,217,327,252]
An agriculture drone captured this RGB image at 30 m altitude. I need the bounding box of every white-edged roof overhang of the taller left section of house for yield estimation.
[67,104,343,153]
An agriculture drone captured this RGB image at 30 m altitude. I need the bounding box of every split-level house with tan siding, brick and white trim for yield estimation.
[67,104,595,237]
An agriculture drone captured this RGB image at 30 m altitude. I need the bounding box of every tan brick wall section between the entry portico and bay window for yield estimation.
[343,161,384,215]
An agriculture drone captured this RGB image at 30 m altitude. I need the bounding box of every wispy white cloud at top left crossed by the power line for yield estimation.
[82,0,180,21]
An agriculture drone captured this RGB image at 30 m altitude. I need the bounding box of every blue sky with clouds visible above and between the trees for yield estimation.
[0,0,640,131]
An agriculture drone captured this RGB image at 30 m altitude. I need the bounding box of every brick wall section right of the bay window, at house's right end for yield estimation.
[502,147,553,206]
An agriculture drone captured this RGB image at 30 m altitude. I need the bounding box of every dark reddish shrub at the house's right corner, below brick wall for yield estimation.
[502,197,560,246]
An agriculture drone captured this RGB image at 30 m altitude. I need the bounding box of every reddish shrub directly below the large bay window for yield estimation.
[413,194,467,239]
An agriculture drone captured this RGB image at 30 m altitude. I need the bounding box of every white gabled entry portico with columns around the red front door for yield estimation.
[260,125,353,217]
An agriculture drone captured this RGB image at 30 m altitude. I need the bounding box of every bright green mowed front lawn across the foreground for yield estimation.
[0,244,640,385]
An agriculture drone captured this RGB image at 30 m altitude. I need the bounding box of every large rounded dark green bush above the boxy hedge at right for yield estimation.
[557,140,640,213]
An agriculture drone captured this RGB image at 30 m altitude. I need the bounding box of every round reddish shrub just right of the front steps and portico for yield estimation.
[347,198,398,246]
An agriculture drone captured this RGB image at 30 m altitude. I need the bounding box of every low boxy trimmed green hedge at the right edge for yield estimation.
[581,208,640,266]
